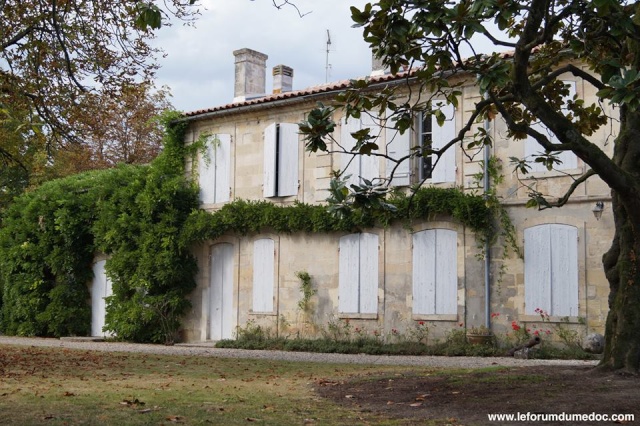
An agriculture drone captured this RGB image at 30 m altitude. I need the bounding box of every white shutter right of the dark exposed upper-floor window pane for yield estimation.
[431,104,456,183]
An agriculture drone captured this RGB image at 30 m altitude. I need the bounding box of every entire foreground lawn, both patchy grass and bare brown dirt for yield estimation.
[0,345,640,426]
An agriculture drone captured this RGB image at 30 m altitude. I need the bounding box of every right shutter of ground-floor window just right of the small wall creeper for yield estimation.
[359,234,378,314]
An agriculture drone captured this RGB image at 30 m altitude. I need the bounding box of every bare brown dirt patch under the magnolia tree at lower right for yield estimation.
[316,366,640,425]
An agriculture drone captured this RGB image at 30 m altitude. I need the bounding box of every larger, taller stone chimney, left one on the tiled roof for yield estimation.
[233,48,268,102]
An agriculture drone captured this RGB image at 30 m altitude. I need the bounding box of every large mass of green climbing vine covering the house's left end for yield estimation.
[0,113,198,342]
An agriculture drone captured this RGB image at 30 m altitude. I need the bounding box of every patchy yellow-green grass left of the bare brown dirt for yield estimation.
[0,346,427,426]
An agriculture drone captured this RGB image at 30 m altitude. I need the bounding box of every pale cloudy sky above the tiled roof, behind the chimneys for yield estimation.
[153,0,371,112]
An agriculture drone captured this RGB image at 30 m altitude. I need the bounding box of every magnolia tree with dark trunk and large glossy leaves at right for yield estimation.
[300,0,640,373]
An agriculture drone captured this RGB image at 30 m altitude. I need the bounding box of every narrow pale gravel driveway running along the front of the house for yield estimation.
[0,336,597,368]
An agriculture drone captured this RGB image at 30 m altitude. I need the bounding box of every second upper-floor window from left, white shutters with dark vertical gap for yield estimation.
[263,123,299,197]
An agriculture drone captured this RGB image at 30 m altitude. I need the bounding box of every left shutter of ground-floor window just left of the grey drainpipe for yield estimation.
[412,230,436,315]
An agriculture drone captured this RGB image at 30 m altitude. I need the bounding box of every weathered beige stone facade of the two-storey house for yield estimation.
[179,54,613,341]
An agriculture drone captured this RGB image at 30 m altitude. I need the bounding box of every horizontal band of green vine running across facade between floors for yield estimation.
[182,187,492,244]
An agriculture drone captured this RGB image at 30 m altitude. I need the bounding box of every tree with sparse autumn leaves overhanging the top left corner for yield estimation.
[0,0,198,151]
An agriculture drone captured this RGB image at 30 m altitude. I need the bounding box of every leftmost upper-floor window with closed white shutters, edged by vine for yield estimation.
[198,134,231,204]
